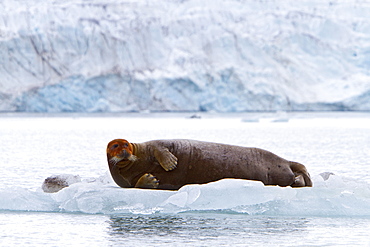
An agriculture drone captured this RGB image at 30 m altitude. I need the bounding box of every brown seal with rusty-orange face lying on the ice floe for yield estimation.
[107,139,312,190]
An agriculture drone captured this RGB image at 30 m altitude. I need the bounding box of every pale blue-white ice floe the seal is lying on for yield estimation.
[0,172,370,216]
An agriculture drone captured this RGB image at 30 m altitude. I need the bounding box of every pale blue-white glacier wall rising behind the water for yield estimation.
[0,0,370,112]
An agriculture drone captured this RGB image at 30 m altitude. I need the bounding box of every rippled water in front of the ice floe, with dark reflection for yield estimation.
[0,212,370,246]
